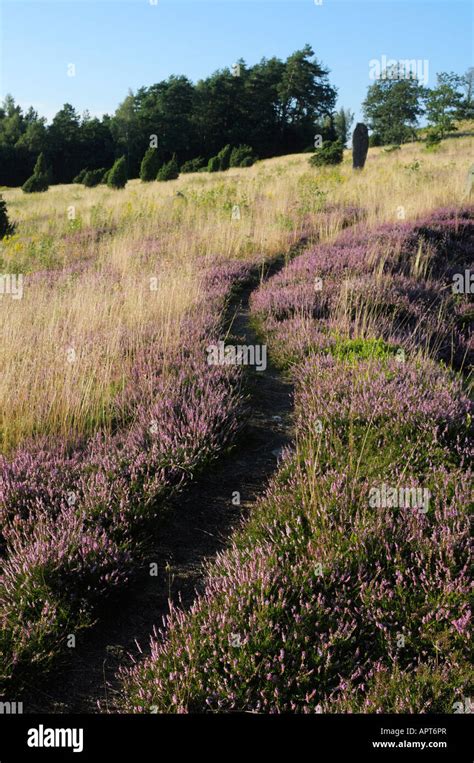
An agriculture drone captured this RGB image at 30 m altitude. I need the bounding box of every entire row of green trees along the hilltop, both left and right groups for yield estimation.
[0,45,474,190]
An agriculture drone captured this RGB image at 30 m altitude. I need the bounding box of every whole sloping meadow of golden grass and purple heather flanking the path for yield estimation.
[0,136,474,712]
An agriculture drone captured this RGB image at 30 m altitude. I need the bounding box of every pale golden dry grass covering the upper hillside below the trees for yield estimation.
[0,137,474,450]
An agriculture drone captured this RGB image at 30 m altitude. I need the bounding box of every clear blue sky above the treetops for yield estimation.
[0,0,473,124]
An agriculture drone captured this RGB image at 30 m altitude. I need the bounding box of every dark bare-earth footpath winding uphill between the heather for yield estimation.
[23,261,293,713]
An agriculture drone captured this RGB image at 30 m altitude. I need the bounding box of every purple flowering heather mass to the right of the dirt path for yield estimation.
[121,206,472,713]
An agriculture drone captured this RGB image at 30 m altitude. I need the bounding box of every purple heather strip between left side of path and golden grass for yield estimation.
[0,263,254,681]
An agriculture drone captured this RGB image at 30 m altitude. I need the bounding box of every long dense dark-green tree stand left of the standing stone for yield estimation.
[0,45,337,186]
